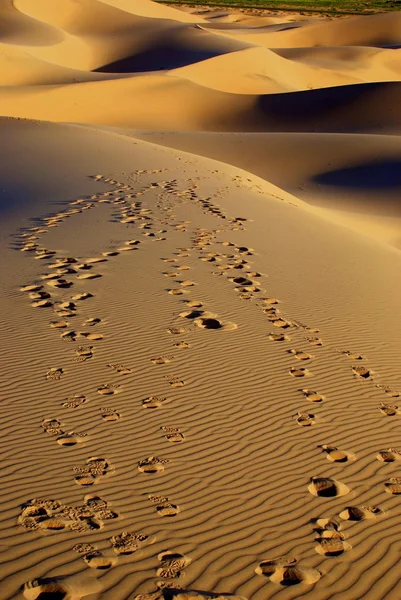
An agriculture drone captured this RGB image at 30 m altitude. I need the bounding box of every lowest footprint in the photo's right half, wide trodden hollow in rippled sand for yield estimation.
[255,557,321,587]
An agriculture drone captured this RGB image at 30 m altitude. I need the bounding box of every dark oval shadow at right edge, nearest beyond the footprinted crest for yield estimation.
[312,158,401,190]
